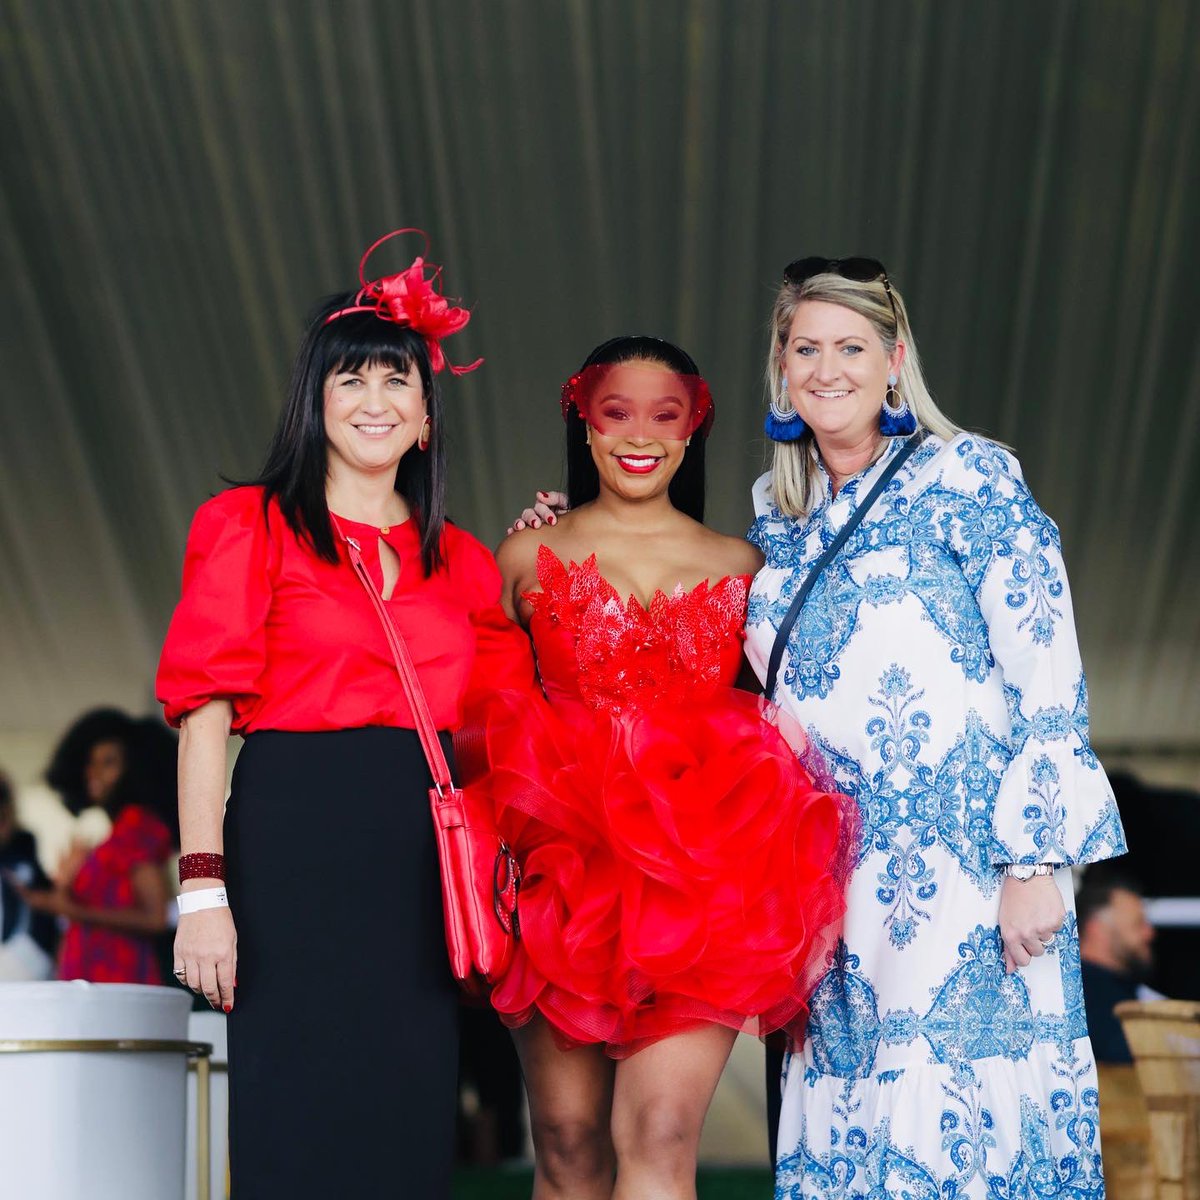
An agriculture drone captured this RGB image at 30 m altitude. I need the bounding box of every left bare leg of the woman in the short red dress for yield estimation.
[512,1016,614,1200]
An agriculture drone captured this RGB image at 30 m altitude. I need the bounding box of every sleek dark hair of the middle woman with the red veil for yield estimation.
[566,334,706,521]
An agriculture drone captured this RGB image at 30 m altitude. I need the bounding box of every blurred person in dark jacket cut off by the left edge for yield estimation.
[0,772,59,983]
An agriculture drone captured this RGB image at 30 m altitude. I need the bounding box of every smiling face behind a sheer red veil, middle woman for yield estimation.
[587,360,692,499]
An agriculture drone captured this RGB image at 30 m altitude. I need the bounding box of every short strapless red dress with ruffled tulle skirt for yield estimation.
[472,546,848,1057]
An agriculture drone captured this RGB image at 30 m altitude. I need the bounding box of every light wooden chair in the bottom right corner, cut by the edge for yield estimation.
[1116,1000,1200,1200]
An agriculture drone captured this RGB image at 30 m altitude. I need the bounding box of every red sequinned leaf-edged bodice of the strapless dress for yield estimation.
[524,546,751,715]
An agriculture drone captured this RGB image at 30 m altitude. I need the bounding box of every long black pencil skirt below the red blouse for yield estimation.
[226,728,458,1200]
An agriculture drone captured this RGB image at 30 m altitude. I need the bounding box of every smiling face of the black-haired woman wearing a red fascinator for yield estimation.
[325,362,426,474]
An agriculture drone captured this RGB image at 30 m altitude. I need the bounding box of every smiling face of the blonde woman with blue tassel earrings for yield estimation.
[781,300,905,448]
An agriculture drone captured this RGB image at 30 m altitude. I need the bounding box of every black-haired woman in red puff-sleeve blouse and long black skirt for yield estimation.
[158,236,532,1200]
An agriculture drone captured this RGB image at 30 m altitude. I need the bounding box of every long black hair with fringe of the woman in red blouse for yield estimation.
[244,302,446,576]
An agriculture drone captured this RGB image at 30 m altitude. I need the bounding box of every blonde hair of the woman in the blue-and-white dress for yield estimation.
[767,272,961,517]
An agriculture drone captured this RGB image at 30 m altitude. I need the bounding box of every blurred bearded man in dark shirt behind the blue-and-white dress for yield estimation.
[1075,871,1157,1063]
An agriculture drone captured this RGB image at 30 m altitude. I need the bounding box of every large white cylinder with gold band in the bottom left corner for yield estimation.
[0,982,191,1200]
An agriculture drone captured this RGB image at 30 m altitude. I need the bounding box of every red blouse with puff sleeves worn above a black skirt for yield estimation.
[156,487,533,733]
